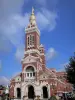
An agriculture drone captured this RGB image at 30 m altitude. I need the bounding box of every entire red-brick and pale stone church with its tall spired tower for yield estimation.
[9,9,72,100]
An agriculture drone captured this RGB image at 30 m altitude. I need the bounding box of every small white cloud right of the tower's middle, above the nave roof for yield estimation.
[46,48,57,61]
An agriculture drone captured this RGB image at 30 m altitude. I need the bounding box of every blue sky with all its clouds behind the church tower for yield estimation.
[0,0,75,84]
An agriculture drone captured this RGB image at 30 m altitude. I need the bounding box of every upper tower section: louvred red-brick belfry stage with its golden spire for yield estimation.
[25,8,40,51]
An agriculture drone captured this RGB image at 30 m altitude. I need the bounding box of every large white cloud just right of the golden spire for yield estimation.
[36,8,57,31]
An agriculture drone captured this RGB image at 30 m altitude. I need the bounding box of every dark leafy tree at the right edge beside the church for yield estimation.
[66,53,75,88]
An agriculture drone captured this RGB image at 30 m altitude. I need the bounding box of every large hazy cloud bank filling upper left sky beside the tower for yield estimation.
[0,0,27,52]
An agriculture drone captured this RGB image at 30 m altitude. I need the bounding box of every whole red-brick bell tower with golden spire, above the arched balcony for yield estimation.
[22,8,45,70]
